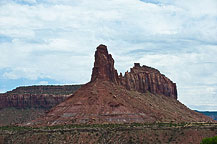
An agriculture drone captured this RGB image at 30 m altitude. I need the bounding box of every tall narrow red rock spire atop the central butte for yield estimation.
[91,45,119,83]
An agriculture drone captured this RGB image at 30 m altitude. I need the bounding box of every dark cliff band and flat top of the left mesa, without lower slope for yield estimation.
[0,85,81,109]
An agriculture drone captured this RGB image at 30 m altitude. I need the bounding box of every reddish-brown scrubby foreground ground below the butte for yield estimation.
[0,122,217,144]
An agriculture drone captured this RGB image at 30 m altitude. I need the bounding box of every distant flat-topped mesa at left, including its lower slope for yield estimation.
[0,85,81,126]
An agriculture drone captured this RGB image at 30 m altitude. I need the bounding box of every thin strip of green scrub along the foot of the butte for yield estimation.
[0,122,217,131]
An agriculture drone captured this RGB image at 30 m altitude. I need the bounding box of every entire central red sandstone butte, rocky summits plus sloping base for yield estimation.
[26,45,214,126]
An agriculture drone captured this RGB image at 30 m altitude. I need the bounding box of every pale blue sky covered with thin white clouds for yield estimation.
[0,0,217,111]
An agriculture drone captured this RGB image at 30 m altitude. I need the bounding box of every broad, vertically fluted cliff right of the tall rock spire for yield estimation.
[119,63,177,99]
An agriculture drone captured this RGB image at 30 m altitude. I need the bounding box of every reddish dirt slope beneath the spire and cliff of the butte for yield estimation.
[29,80,213,125]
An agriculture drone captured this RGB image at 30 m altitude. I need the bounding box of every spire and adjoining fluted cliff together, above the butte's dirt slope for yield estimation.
[91,45,177,99]
